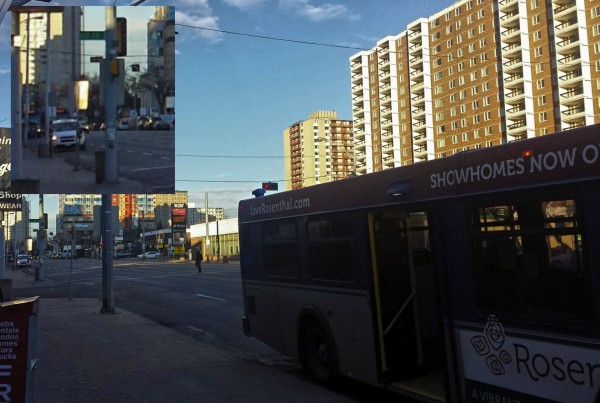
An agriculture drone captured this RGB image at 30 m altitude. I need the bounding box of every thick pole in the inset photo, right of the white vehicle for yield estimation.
[102,6,120,183]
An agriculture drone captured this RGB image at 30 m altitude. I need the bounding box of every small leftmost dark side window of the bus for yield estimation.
[262,221,300,278]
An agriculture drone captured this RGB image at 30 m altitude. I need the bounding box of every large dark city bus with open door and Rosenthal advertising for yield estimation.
[238,125,600,403]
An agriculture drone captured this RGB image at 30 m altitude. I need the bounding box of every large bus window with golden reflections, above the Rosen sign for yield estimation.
[471,200,591,320]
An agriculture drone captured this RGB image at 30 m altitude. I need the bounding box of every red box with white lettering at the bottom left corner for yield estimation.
[0,297,39,403]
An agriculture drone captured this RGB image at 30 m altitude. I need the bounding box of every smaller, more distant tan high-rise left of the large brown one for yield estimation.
[283,111,354,190]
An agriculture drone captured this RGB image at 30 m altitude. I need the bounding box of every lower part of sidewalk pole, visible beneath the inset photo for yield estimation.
[100,194,115,313]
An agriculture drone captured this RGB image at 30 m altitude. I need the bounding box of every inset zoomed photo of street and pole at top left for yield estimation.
[11,6,175,194]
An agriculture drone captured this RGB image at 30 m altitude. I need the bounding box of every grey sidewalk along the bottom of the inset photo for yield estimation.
[11,140,152,194]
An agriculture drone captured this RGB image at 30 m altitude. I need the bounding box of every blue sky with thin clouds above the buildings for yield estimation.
[0,0,452,227]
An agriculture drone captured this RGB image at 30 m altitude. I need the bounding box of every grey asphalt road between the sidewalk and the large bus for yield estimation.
[14,258,412,402]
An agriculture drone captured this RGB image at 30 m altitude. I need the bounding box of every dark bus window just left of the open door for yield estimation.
[308,217,356,281]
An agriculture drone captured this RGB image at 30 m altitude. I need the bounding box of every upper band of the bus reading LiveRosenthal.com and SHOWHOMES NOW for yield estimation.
[238,125,600,223]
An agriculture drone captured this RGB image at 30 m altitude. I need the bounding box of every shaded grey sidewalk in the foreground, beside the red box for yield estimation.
[5,269,347,403]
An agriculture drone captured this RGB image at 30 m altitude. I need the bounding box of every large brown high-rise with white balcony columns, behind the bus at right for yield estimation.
[350,0,600,174]
